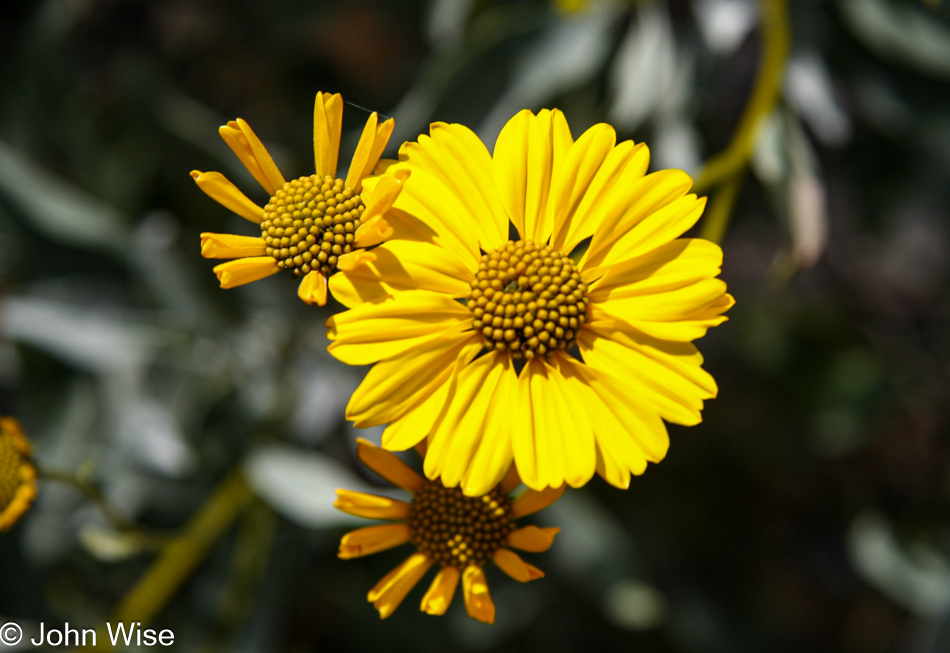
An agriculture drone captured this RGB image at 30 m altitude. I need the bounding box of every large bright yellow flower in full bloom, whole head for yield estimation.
[327,110,734,495]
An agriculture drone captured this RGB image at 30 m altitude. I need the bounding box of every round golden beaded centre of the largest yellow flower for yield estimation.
[468,240,588,359]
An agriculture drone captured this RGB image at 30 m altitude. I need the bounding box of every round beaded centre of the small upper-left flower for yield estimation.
[261,175,365,277]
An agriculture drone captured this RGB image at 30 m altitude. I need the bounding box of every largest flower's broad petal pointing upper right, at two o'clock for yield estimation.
[581,170,703,268]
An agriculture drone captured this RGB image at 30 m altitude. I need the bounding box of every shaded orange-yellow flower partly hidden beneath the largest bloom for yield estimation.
[333,439,564,623]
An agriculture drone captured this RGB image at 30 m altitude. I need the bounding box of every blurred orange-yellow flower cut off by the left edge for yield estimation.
[0,417,36,531]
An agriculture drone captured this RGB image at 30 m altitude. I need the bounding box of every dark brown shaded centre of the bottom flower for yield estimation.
[409,481,514,569]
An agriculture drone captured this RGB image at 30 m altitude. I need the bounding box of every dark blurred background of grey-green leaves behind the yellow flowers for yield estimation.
[0,0,950,653]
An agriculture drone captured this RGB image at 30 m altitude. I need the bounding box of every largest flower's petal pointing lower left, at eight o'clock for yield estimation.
[346,332,482,428]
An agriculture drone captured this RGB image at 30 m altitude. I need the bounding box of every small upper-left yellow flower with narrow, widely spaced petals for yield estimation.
[191,93,405,306]
